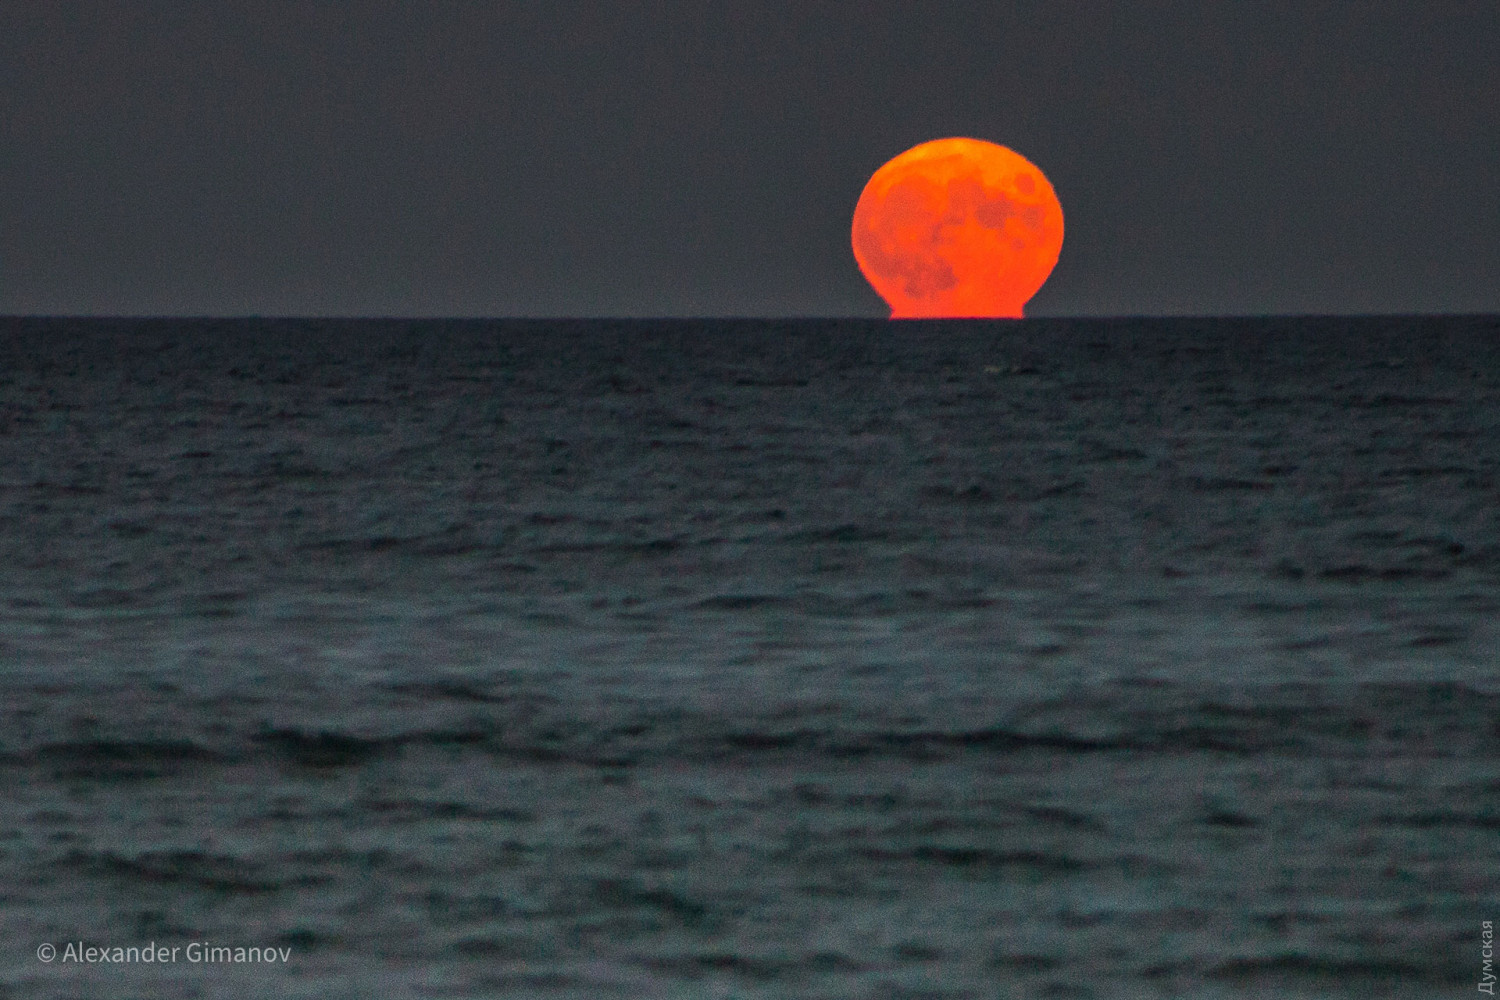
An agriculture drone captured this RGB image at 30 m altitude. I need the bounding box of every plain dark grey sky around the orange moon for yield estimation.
[0,0,1500,316]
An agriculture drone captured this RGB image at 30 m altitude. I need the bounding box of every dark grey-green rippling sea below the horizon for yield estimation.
[0,318,1500,1000]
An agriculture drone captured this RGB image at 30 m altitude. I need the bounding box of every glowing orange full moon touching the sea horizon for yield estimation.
[854,138,1062,319]
